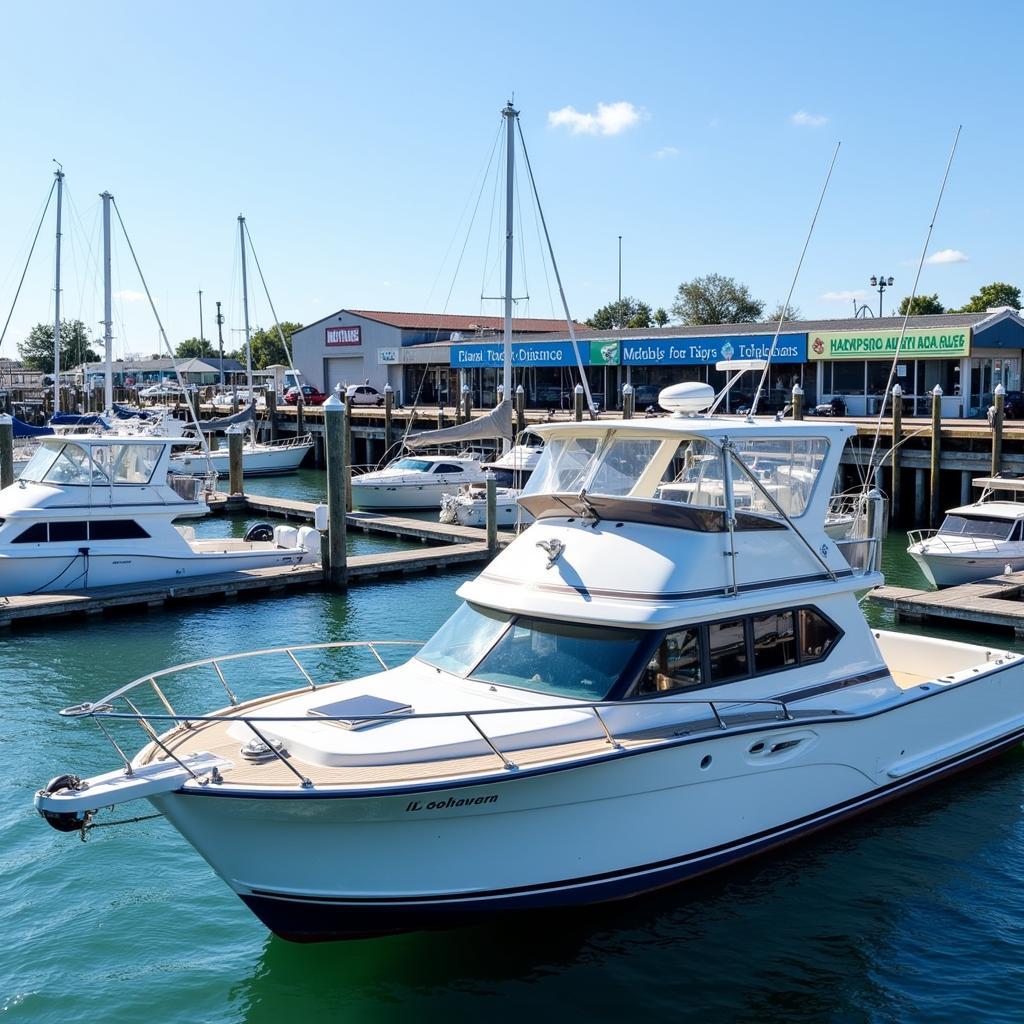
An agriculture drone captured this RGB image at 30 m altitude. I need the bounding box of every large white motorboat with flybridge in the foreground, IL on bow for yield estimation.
[29,393,1024,941]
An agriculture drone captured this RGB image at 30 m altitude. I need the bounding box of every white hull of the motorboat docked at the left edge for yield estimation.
[0,542,313,597]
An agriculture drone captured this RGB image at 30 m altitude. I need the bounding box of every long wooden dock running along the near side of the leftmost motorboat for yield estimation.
[0,544,494,628]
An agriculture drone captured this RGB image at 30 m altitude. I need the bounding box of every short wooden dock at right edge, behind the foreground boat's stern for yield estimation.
[869,572,1024,639]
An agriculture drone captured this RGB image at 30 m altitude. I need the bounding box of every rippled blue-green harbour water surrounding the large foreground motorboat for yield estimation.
[6,512,1024,1024]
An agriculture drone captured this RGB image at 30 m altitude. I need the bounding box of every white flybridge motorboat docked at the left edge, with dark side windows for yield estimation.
[0,434,319,596]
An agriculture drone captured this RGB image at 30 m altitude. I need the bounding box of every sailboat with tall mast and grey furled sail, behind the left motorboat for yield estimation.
[170,213,313,477]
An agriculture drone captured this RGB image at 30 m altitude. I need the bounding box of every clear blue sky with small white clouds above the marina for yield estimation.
[0,0,1024,356]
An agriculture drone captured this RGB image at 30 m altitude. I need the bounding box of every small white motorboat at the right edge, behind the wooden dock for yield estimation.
[906,476,1024,587]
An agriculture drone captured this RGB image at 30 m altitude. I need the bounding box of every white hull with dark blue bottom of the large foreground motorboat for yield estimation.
[152,663,1024,941]
